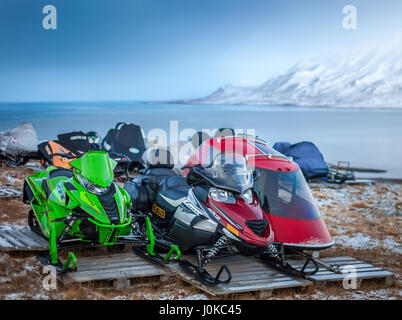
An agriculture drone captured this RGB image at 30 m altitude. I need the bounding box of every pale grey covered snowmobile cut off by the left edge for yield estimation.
[0,122,39,165]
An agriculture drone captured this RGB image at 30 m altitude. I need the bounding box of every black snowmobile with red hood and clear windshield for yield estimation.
[124,149,274,285]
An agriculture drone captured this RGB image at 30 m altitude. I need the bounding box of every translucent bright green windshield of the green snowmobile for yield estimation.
[70,151,117,188]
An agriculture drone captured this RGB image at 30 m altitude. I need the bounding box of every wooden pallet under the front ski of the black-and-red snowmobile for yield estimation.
[171,255,312,298]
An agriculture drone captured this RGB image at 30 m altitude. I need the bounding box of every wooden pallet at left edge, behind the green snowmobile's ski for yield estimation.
[0,226,49,251]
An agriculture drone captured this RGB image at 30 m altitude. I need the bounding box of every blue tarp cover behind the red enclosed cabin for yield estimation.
[273,141,329,179]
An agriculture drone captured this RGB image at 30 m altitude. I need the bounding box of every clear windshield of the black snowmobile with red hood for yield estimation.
[203,153,253,193]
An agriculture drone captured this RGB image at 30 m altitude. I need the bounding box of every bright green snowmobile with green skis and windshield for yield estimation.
[23,151,180,273]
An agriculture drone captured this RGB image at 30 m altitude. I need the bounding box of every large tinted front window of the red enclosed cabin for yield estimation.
[254,168,321,220]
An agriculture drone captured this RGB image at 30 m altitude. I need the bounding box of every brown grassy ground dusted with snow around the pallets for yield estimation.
[0,162,402,300]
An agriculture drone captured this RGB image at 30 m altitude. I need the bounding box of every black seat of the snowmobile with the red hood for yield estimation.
[156,176,190,220]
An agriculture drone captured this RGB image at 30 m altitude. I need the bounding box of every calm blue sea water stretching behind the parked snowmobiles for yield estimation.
[0,102,402,178]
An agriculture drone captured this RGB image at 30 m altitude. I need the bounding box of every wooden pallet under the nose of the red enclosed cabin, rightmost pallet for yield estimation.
[290,257,394,287]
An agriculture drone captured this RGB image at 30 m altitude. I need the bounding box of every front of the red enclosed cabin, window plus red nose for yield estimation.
[254,166,333,249]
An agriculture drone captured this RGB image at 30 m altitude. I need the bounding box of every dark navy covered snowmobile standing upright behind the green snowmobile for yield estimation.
[101,122,146,171]
